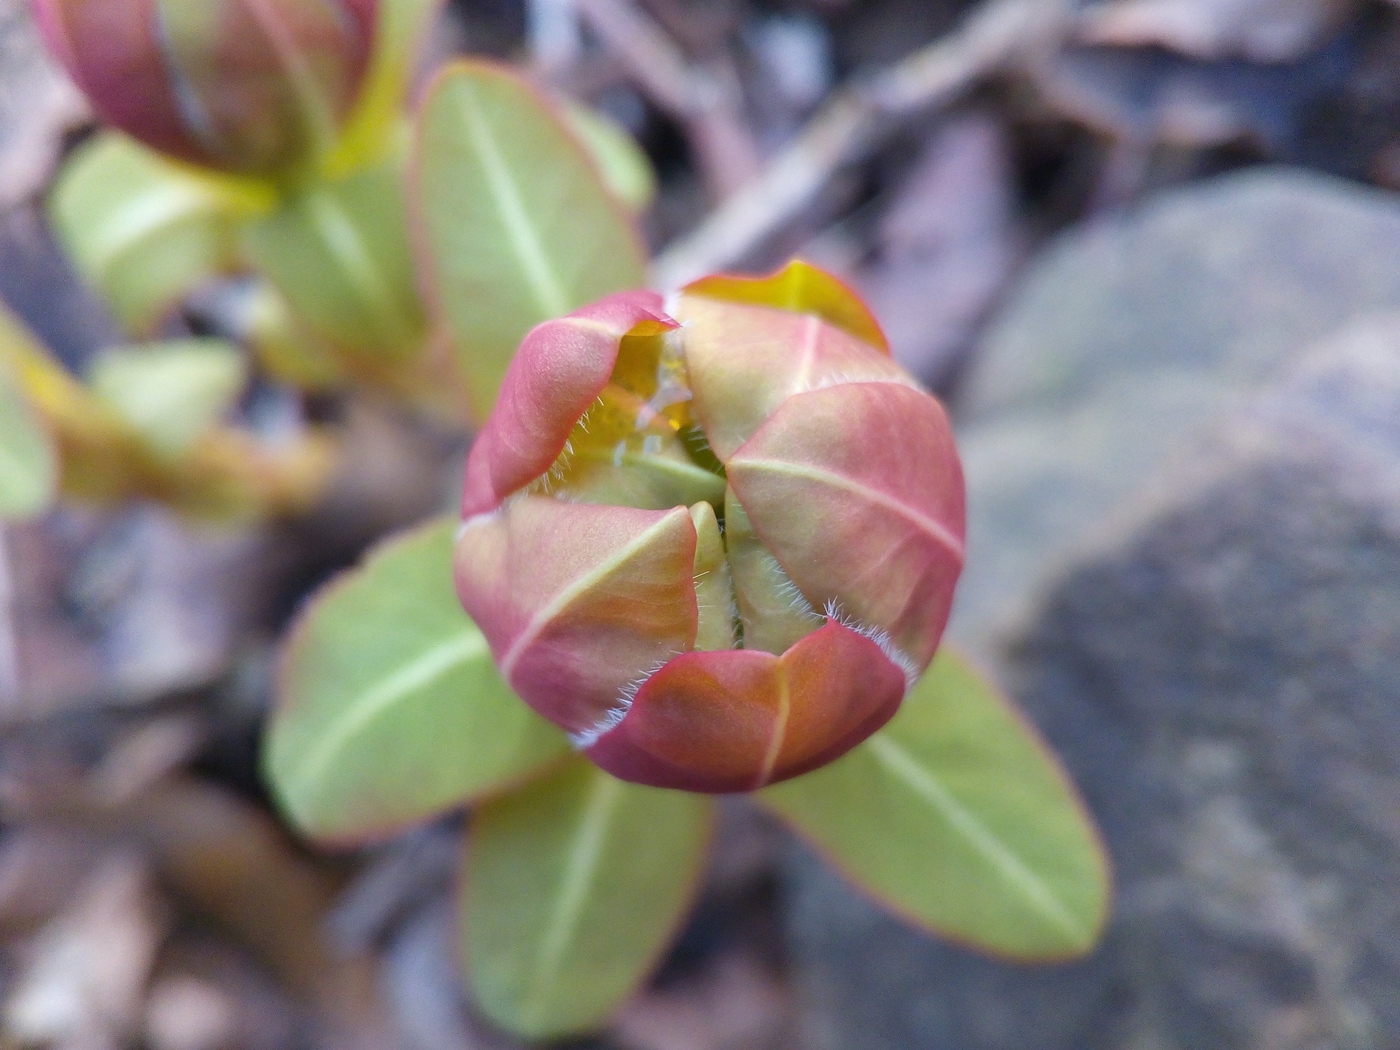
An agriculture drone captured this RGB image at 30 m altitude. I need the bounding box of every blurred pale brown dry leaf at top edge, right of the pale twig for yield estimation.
[1078,0,1358,62]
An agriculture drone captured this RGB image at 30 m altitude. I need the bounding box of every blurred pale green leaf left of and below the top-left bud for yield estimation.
[49,132,274,336]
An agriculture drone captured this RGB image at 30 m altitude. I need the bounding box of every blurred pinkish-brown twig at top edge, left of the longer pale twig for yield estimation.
[574,0,759,200]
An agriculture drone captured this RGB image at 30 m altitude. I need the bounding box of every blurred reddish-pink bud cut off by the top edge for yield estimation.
[34,0,378,175]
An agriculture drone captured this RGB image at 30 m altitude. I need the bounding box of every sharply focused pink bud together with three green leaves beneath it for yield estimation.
[266,263,1107,1037]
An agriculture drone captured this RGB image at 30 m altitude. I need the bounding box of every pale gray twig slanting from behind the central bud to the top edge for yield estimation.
[652,0,1071,288]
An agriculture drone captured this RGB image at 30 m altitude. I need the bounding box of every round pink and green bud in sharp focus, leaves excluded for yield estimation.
[456,263,965,792]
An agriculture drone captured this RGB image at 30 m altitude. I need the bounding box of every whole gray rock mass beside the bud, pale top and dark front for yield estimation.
[787,174,1400,1050]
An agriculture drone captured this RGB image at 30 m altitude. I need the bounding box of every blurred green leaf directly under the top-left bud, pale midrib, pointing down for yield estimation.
[245,149,424,358]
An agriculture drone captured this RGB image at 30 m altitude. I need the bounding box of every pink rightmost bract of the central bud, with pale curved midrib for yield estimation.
[729,382,965,668]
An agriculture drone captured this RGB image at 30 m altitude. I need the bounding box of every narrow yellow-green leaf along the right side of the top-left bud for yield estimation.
[323,0,444,179]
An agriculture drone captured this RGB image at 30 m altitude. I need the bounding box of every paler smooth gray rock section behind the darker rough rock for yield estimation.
[952,169,1400,650]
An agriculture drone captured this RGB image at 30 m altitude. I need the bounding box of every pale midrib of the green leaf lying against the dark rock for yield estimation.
[865,731,1084,942]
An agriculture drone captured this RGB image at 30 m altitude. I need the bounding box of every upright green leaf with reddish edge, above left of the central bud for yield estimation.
[413,62,645,419]
